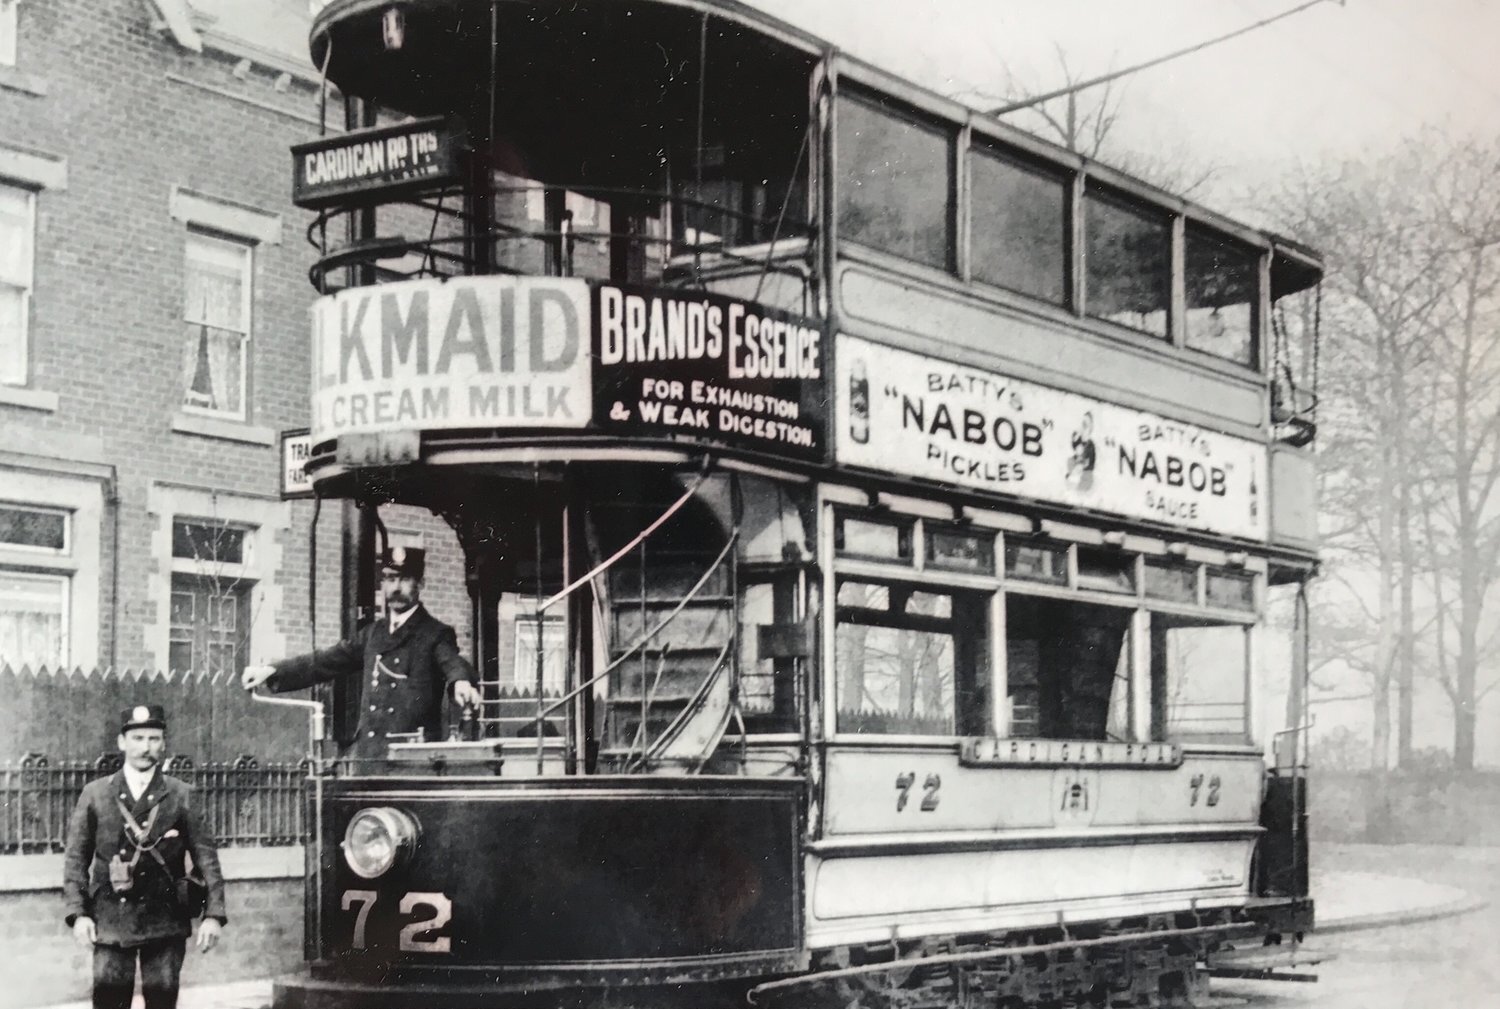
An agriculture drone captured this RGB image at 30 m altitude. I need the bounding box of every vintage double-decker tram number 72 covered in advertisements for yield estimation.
[276,0,1322,1009]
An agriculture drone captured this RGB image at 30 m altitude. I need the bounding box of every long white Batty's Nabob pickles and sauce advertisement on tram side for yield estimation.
[834,336,1268,540]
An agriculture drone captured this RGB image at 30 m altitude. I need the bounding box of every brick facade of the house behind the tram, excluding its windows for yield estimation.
[0,0,468,683]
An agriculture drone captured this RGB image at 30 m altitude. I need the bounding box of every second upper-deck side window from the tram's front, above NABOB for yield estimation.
[969,148,1068,304]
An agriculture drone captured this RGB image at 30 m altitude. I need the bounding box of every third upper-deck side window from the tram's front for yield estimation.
[1083,190,1172,337]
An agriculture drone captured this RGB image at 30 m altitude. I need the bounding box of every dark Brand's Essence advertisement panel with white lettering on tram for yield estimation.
[594,283,828,462]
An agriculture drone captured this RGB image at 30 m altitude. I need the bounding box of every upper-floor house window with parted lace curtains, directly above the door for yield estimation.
[182,232,251,420]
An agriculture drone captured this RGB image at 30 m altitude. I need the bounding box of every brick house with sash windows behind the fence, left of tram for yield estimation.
[0,0,468,759]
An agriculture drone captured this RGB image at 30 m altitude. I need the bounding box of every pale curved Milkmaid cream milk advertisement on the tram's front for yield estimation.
[312,276,591,444]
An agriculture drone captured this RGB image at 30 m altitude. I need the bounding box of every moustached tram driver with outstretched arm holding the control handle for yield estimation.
[240,547,480,759]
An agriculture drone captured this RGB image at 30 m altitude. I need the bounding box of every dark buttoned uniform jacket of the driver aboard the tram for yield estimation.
[266,604,474,757]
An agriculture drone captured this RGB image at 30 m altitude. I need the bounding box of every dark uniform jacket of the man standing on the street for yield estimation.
[63,768,228,946]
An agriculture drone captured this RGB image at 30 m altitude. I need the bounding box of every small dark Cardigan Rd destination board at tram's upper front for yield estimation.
[291,117,464,210]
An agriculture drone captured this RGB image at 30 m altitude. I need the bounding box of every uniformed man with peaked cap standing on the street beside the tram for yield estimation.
[63,705,228,1009]
